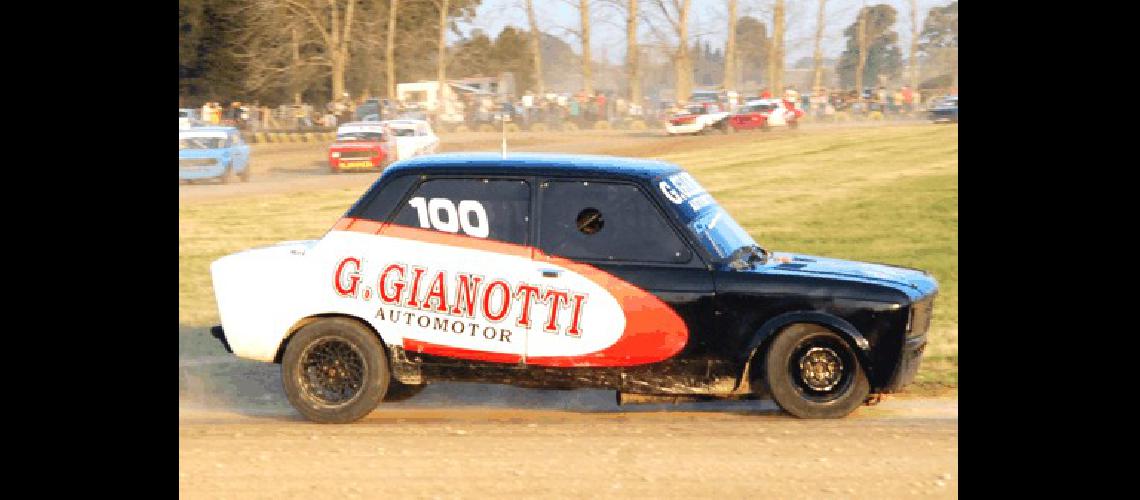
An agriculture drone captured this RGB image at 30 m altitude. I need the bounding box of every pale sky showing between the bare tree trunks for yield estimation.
[459,0,951,66]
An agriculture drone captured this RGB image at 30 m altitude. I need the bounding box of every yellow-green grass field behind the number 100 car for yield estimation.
[178,124,958,393]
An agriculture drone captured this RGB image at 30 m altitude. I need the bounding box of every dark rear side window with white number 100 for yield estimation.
[392,179,530,245]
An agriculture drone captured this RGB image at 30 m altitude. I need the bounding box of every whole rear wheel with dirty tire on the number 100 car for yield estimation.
[282,318,391,424]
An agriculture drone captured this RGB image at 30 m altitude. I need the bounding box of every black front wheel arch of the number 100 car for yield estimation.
[740,311,872,385]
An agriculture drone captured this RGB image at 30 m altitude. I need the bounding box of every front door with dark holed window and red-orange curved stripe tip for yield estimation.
[527,179,715,387]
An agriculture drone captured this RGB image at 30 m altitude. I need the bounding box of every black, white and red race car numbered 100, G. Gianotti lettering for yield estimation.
[211,154,938,423]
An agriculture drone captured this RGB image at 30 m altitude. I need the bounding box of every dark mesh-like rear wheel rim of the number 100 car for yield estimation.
[298,338,368,407]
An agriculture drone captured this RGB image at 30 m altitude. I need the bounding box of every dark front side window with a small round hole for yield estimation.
[539,180,692,263]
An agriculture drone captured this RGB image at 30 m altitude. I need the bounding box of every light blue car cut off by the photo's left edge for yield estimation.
[178,126,250,183]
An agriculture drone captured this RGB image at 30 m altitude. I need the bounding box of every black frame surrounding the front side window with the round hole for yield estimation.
[530,175,709,269]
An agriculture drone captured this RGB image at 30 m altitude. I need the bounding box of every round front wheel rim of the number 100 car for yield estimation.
[788,335,856,402]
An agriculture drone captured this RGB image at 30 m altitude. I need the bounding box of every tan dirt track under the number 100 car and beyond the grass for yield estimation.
[179,120,958,499]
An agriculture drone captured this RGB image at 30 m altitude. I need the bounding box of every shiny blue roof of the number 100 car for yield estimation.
[384,153,681,184]
